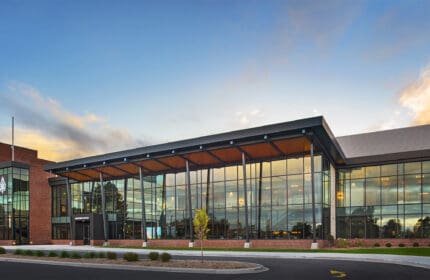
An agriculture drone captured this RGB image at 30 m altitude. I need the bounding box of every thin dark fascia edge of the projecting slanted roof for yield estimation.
[44,116,339,171]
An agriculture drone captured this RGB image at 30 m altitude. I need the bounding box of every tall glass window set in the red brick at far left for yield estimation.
[0,167,30,244]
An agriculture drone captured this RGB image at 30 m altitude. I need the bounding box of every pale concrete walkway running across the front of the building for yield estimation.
[2,245,430,269]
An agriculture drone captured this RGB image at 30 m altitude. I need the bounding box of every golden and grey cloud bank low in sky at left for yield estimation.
[0,82,143,161]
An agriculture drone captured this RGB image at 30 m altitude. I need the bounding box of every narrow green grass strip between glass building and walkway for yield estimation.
[102,246,430,257]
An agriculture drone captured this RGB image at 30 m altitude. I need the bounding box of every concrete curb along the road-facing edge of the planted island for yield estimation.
[0,257,269,275]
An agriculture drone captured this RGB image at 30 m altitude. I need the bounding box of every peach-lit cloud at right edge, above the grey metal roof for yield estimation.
[399,64,430,125]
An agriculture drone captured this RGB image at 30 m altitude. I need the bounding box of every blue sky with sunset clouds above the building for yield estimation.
[0,0,430,161]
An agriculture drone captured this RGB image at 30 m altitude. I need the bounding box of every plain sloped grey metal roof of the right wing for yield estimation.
[336,125,430,164]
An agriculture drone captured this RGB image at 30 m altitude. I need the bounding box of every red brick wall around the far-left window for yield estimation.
[0,143,53,244]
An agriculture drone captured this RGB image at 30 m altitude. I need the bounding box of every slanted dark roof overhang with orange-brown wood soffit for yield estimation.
[45,117,344,181]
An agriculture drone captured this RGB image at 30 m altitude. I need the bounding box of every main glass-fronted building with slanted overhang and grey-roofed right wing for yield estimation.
[0,117,430,248]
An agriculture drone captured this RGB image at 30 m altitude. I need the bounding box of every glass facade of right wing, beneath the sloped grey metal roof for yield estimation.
[336,161,430,238]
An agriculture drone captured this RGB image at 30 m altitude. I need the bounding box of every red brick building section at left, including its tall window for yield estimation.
[0,143,53,245]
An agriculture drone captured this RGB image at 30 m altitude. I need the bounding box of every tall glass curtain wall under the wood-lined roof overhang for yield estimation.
[52,155,330,239]
